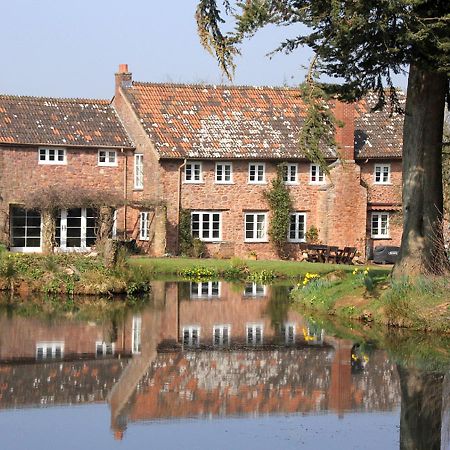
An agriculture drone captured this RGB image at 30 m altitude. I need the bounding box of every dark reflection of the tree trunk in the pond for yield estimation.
[397,365,444,450]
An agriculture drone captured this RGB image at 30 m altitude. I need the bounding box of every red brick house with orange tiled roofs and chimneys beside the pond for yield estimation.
[0,65,401,259]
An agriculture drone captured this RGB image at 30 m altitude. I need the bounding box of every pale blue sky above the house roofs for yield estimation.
[0,0,406,98]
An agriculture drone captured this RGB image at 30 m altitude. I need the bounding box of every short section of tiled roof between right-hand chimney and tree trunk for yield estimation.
[355,91,406,158]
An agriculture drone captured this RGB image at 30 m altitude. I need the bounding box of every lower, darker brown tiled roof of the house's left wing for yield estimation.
[0,95,133,147]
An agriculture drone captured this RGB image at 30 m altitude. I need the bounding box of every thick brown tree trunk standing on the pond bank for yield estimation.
[393,65,449,277]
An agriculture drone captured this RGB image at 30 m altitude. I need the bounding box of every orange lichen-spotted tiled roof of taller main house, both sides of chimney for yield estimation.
[122,82,402,159]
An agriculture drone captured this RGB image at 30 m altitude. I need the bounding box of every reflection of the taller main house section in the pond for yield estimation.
[109,282,399,438]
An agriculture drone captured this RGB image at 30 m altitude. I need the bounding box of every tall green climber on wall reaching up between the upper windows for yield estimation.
[264,164,292,258]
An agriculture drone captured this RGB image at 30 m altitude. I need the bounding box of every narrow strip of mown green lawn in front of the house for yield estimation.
[130,257,390,278]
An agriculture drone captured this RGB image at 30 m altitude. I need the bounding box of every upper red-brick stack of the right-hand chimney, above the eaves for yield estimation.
[334,101,355,161]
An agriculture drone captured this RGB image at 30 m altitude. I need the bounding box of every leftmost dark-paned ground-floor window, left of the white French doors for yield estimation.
[10,206,41,252]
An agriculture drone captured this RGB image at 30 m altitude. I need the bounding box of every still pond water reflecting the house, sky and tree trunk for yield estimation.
[0,281,450,450]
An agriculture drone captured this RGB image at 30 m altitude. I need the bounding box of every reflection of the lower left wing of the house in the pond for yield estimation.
[0,315,133,409]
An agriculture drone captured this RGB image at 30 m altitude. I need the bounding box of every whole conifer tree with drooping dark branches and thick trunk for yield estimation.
[196,0,450,276]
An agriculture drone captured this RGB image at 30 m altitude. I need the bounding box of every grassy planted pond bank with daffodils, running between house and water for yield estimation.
[0,252,450,333]
